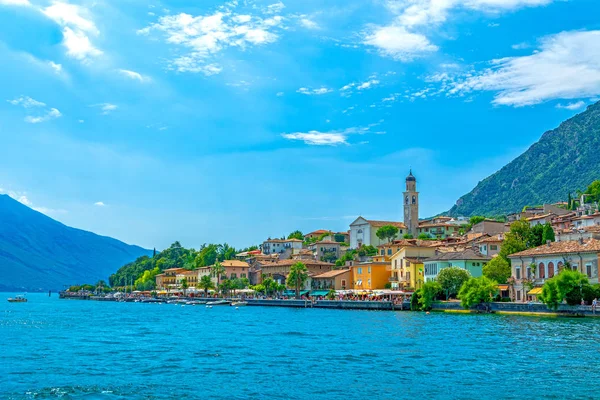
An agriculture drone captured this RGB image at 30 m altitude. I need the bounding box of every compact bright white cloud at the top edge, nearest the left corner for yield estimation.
[41,1,102,61]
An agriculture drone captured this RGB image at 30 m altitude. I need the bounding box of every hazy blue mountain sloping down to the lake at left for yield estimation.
[0,195,151,291]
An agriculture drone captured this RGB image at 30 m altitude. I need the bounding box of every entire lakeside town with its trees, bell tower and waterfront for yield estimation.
[63,171,600,312]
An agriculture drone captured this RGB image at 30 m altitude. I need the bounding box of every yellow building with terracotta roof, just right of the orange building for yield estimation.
[390,244,435,289]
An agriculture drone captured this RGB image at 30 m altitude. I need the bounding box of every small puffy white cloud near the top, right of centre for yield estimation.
[363,26,438,61]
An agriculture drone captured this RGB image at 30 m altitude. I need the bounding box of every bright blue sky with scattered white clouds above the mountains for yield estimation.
[0,0,600,249]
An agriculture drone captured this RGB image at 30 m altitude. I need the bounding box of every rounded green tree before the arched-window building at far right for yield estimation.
[539,268,589,310]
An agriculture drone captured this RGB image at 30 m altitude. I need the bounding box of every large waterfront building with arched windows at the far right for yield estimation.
[508,239,600,301]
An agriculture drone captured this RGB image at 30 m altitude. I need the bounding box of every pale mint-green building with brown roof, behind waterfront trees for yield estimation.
[423,248,492,282]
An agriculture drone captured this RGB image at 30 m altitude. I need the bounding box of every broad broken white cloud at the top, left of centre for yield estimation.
[138,2,284,75]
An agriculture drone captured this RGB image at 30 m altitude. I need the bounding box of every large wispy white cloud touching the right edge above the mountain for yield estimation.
[448,31,600,106]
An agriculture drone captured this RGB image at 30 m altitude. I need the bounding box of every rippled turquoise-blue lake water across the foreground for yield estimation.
[0,293,600,400]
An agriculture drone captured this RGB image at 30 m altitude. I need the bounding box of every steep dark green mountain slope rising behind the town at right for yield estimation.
[448,102,600,216]
